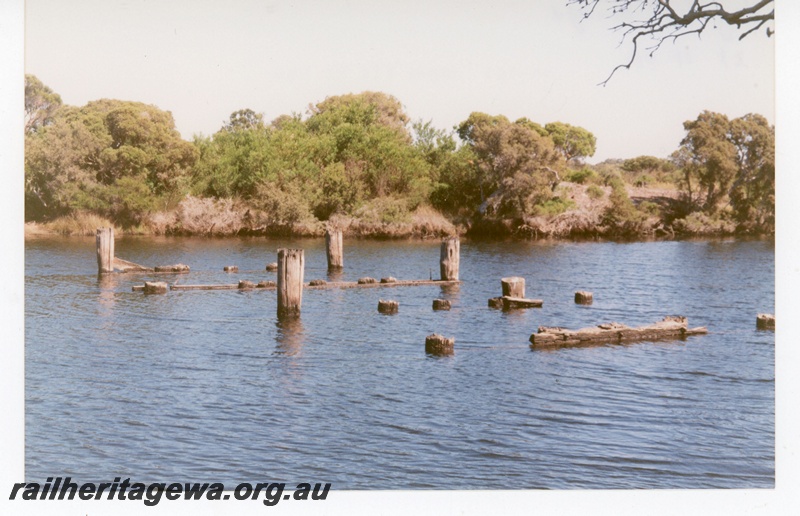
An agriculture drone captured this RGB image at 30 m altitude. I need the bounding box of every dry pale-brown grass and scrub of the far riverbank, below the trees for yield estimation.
[25,181,762,240]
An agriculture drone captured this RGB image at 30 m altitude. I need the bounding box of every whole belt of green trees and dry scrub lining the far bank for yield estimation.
[25,75,775,239]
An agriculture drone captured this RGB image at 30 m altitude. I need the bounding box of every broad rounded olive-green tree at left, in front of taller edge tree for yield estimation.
[25,99,197,225]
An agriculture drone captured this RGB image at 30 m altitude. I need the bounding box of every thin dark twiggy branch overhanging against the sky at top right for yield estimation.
[567,0,775,85]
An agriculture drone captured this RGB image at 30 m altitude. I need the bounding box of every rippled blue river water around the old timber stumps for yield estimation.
[25,237,775,489]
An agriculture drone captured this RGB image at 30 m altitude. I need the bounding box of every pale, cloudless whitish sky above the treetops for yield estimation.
[25,0,775,162]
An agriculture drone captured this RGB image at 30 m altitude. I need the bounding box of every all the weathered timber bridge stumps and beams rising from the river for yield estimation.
[97,228,775,355]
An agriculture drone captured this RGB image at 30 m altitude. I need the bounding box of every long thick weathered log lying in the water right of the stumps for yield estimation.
[530,317,708,349]
